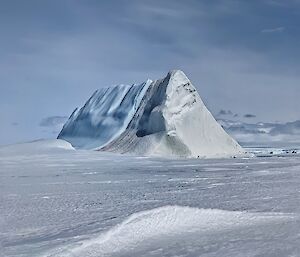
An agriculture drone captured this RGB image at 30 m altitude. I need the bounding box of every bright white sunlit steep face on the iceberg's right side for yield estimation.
[163,71,242,157]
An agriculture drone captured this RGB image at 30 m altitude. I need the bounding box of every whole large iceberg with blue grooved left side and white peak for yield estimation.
[58,70,244,158]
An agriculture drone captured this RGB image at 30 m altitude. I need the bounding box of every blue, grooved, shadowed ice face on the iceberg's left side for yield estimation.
[58,80,152,149]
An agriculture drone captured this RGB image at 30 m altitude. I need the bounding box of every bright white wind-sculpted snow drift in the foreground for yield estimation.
[44,206,292,257]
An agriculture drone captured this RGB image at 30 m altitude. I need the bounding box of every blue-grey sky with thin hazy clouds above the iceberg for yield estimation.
[0,0,300,145]
